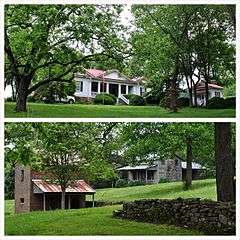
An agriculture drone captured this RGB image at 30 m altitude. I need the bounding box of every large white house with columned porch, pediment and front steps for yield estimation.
[74,69,145,104]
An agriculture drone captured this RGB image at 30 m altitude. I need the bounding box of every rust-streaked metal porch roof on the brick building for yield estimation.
[32,179,96,193]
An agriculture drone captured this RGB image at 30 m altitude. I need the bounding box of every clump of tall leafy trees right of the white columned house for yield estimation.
[132,5,235,110]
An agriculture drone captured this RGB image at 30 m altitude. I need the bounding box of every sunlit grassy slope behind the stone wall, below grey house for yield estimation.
[89,179,217,202]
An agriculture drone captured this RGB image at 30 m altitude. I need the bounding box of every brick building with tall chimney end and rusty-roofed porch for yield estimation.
[15,165,95,213]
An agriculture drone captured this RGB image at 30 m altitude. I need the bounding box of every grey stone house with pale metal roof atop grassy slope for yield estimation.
[117,156,205,184]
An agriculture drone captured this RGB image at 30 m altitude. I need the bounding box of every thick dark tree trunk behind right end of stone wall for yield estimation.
[215,123,235,202]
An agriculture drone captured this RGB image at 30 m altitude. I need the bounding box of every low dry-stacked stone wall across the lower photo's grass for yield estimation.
[113,198,236,235]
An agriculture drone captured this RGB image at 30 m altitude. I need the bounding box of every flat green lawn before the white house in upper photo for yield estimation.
[5,102,235,118]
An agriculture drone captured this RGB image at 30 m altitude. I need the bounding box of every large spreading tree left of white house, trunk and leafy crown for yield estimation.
[4,5,128,111]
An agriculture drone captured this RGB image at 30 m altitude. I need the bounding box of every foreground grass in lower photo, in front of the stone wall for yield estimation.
[5,201,202,235]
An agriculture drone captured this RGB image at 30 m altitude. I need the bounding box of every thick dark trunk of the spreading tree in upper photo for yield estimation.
[16,78,29,112]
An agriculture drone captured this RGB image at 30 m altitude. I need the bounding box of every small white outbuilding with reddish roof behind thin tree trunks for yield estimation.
[193,81,223,106]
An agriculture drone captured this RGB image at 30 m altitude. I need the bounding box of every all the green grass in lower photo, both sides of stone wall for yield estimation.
[5,179,216,235]
